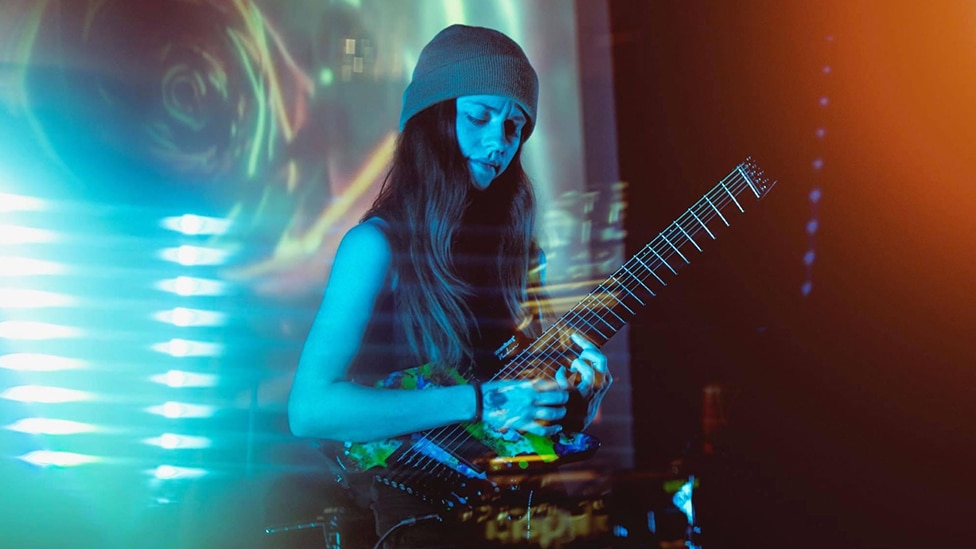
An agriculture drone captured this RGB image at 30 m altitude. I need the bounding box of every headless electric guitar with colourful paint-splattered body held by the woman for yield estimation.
[322,158,776,511]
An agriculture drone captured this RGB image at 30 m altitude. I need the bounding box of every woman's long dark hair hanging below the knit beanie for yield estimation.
[363,99,535,366]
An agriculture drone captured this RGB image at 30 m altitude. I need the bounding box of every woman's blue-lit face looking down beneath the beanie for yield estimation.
[457,95,526,190]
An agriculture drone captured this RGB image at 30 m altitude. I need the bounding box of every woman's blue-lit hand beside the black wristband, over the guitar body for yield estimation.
[481,379,569,436]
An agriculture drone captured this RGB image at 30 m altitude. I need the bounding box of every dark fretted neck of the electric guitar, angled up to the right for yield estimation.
[498,158,776,377]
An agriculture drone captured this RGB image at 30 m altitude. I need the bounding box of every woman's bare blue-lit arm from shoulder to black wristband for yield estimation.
[288,222,475,441]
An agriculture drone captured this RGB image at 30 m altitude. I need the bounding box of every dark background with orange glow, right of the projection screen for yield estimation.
[610,1,976,547]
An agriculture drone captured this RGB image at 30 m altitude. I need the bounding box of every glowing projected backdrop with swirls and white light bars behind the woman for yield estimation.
[0,0,629,540]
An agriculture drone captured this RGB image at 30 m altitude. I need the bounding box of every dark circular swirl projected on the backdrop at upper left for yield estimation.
[8,0,310,202]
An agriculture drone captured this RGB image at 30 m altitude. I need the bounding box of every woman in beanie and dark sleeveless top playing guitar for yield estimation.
[289,25,611,547]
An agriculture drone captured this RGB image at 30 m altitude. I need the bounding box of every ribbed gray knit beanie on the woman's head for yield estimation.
[400,25,539,142]
